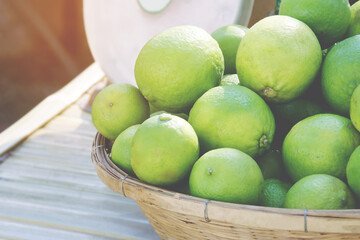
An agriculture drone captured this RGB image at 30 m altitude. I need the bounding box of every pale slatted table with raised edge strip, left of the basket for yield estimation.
[0,64,159,240]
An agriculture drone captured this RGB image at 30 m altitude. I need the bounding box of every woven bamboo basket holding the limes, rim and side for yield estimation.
[92,133,360,239]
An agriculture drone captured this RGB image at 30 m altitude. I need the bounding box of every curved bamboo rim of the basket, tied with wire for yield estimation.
[91,132,360,234]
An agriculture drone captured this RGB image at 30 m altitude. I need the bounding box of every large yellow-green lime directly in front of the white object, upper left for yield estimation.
[135,26,224,112]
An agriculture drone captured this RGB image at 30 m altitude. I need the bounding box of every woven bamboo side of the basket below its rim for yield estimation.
[137,201,359,240]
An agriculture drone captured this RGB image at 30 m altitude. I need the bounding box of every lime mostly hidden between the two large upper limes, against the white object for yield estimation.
[211,25,249,74]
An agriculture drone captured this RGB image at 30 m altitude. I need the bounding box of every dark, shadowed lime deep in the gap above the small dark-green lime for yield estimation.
[256,150,286,179]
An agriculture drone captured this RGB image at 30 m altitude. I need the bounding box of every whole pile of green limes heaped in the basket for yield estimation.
[92,0,360,209]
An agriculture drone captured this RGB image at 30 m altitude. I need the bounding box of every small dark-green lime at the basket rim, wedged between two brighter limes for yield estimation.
[260,178,291,208]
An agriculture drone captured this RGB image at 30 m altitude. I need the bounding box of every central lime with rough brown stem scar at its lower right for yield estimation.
[189,85,275,156]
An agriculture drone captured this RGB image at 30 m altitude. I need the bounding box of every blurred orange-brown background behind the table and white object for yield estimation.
[0,0,275,132]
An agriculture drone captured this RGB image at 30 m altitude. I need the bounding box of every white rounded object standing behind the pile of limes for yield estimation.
[84,0,254,85]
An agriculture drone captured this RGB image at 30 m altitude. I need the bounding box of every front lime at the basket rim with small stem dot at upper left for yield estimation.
[189,148,264,204]
